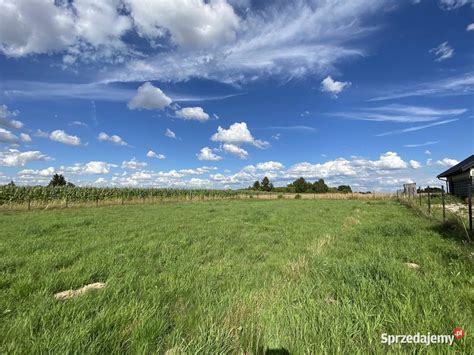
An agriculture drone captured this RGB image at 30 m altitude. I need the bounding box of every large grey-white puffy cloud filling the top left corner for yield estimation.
[0,0,131,60]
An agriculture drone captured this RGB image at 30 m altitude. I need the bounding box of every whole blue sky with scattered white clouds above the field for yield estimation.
[0,0,474,191]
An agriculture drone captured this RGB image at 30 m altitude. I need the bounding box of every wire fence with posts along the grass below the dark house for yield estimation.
[397,186,473,235]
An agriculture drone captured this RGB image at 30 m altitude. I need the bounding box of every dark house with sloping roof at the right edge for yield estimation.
[438,155,474,197]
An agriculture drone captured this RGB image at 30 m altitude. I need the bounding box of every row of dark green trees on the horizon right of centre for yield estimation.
[248,176,352,194]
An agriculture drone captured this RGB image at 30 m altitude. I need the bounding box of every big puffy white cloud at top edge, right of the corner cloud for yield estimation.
[126,0,239,48]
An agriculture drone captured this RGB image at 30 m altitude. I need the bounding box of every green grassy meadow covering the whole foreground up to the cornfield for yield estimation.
[0,200,474,354]
